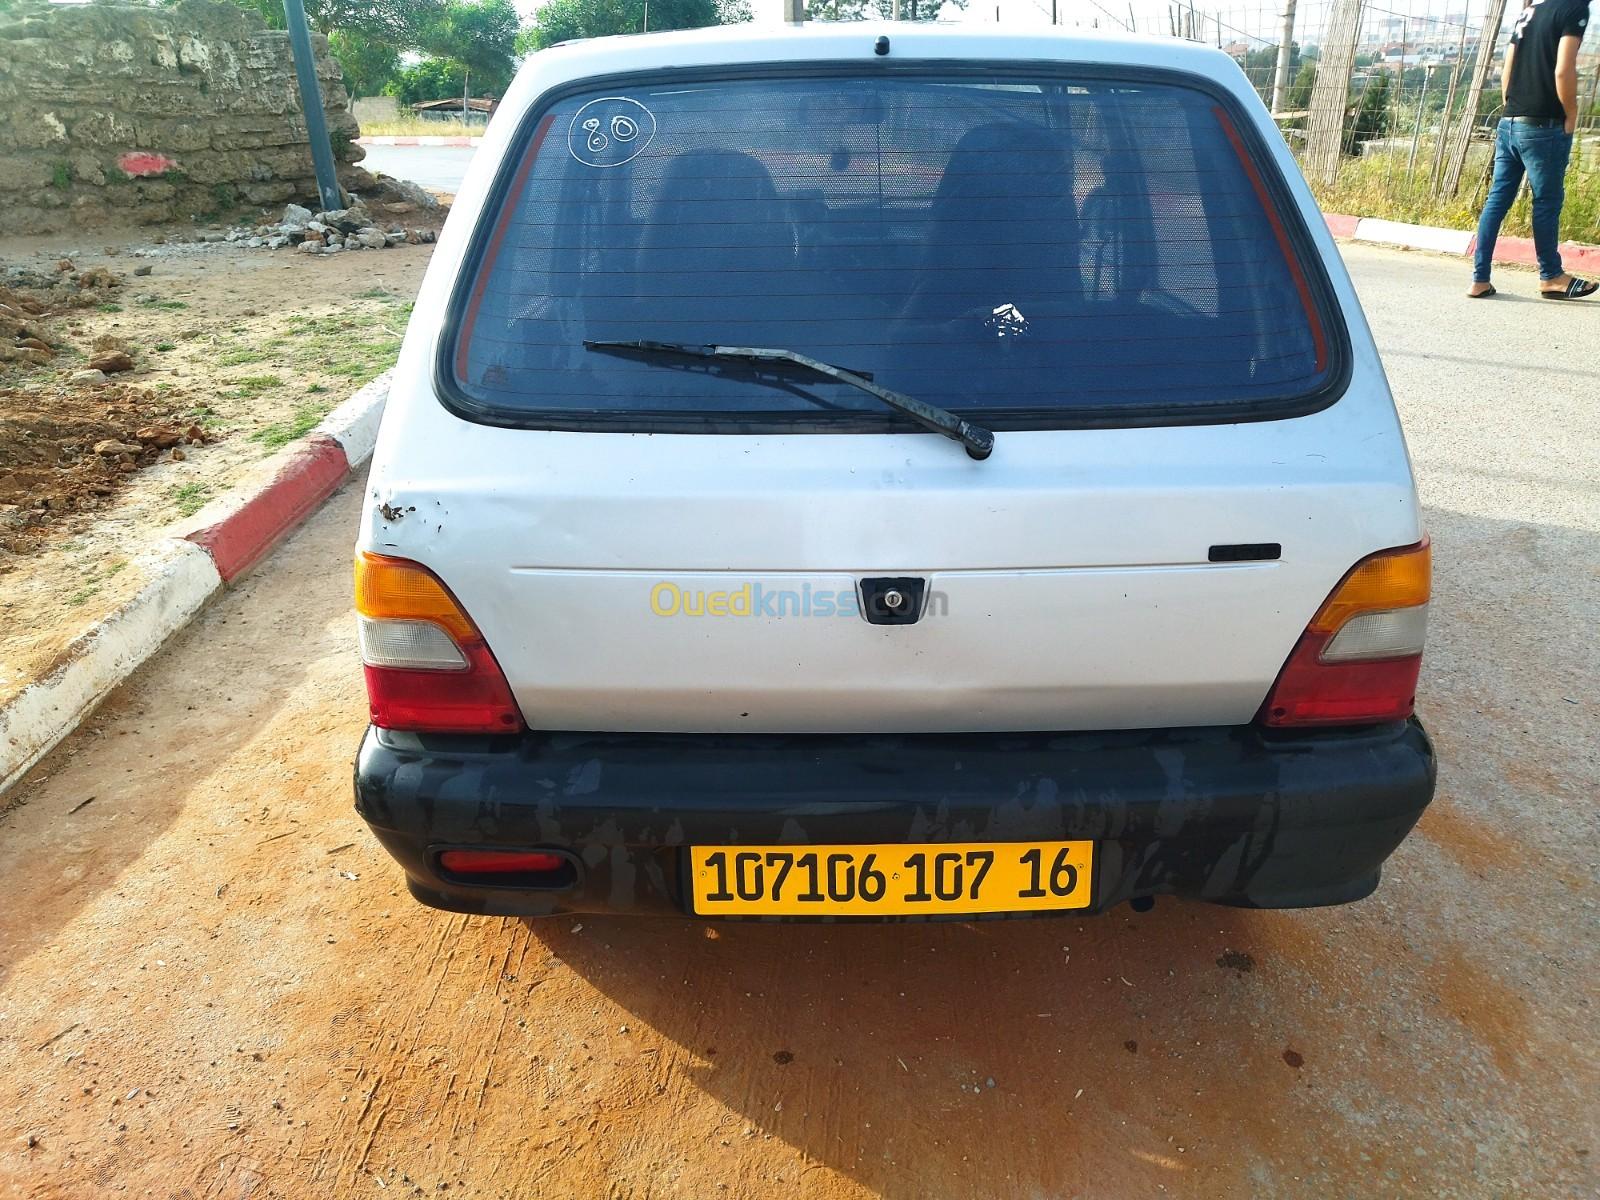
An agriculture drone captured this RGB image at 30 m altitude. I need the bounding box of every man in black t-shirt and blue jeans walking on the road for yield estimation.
[1467,0,1600,299]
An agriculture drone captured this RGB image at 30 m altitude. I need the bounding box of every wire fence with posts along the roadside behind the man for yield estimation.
[1011,0,1600,242]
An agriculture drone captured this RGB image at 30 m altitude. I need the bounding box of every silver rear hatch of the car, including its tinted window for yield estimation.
[363,61,1419,733]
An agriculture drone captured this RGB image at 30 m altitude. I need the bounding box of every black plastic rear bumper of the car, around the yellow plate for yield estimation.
[355,720,1435,920]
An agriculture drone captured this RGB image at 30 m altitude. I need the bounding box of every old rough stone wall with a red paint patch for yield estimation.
[0,0,371,234]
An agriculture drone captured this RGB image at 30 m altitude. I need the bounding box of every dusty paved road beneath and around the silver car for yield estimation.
[0,248,1600,1200]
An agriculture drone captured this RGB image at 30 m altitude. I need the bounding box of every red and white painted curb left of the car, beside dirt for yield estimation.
[0,371,392,792]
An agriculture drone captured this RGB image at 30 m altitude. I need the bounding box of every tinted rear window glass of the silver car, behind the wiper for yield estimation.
[443,75,1330,427]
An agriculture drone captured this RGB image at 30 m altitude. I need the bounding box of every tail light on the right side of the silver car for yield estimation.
[1258,538,1432,726]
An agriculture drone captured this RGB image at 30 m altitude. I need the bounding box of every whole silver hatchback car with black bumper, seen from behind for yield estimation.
[355,24,1435,920]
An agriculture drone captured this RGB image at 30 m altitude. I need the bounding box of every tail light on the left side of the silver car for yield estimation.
[355,554,522,733]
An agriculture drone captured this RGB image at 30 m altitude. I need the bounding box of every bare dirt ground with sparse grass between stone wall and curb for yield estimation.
[0,227,438,698]
